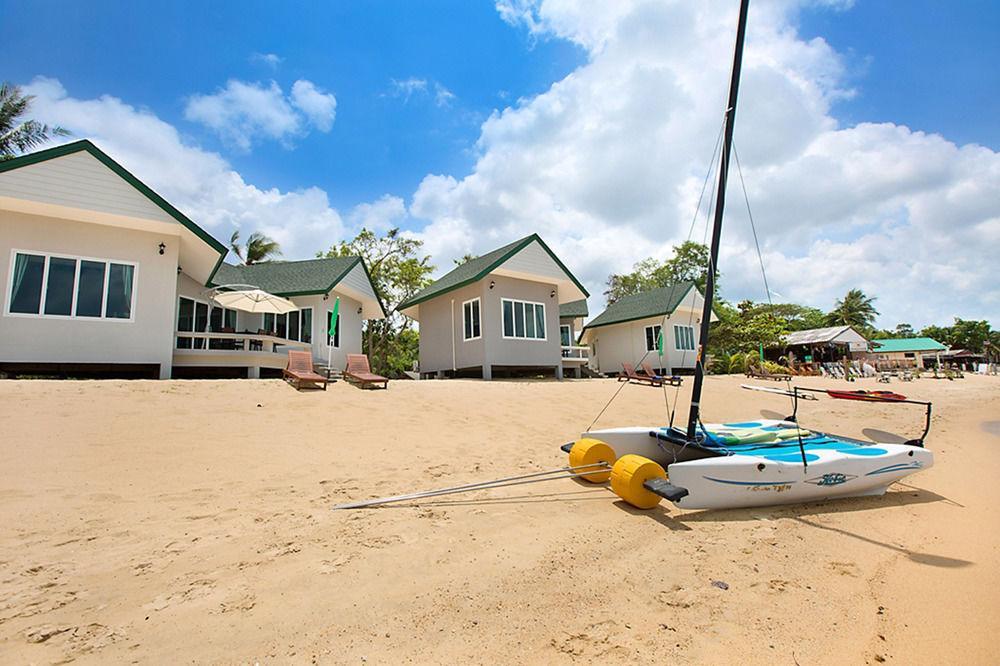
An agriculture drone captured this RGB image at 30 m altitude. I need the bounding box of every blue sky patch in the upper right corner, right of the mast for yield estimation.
[801,0,1000,150]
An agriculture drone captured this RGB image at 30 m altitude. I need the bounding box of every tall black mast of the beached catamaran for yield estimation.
[687,0,750,439]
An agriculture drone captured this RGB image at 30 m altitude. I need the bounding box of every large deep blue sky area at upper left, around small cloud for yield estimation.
[2,0,585,207]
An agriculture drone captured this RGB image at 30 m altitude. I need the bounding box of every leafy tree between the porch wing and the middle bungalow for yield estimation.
[317,229,434,374]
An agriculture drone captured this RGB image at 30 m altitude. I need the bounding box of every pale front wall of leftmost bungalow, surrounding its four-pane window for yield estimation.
[0,209,178,378]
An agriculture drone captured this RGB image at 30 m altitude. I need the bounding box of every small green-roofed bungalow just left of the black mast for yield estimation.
[580,282,716,374]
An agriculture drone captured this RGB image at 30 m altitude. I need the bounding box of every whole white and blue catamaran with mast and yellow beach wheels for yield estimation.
[335,0,934,509]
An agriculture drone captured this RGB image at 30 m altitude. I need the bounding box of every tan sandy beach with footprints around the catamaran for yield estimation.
[0,376,1000,664]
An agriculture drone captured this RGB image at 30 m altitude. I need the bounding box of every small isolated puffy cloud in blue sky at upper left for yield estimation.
[184,79,337,152]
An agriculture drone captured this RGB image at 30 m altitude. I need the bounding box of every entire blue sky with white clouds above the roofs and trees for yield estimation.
[0,0,1000,328]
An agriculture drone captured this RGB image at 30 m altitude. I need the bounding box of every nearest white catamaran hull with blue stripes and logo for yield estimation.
[667,444,934,509]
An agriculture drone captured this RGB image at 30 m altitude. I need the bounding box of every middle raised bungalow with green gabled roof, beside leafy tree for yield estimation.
[399,234,589,379]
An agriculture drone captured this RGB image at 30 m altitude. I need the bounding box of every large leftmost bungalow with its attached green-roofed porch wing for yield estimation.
[0,140,385,378]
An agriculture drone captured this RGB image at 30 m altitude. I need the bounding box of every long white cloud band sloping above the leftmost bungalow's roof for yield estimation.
[24,77,384,259]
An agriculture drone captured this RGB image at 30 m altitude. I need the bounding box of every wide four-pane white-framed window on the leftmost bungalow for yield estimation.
[7,252,136,321]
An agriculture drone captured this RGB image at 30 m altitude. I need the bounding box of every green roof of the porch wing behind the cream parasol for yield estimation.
[213,257,386,314]
